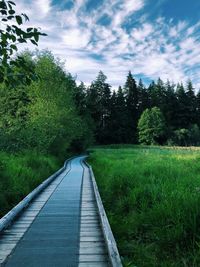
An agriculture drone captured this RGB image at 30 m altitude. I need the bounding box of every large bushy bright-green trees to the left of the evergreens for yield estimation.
[0,51,92,159]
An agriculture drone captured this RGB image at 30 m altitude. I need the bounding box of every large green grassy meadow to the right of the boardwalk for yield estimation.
[89,146,200,267]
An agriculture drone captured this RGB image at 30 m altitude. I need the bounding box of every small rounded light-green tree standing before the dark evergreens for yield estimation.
[138,107,165,145]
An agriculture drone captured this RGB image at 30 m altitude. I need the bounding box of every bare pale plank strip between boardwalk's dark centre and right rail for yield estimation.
[79,163,109,267]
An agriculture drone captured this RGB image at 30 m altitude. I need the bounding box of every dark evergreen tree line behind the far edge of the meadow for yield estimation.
[76,71,200,146]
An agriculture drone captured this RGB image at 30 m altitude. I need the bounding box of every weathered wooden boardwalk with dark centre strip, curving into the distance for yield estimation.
[0,157,122,267]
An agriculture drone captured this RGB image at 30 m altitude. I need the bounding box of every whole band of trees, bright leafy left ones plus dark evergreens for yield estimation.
[0,51,200,159]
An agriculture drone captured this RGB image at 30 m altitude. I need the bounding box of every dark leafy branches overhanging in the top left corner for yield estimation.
[0,0,46,87]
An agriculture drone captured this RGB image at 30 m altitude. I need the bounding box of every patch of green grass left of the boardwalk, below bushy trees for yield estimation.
[0,151,60,217]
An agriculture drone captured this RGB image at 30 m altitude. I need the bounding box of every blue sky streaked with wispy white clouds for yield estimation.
[16,0,200,89]
